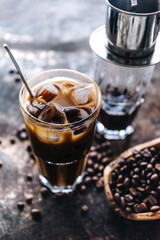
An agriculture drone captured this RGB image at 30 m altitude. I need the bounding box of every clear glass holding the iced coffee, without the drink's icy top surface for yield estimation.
[19,69,101,193]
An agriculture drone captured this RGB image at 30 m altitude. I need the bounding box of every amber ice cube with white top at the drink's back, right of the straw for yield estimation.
[36,83,59,102]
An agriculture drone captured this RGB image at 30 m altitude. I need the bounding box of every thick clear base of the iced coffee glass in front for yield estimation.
[39,174,83,194]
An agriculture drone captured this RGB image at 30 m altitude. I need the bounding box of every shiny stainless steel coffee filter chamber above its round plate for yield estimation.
[105,0,160,58]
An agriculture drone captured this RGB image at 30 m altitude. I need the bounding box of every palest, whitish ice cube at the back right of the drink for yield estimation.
[73,85,91,105]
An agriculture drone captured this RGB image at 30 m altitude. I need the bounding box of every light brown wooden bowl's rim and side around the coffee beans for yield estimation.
[104,138,160,221]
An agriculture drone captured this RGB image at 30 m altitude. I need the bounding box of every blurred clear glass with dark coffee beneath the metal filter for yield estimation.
[94,56,155,140]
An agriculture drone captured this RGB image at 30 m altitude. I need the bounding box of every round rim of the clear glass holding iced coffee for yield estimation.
[19,68,102,128]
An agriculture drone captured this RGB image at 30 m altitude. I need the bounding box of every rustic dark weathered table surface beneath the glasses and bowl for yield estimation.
[0,0,160,240]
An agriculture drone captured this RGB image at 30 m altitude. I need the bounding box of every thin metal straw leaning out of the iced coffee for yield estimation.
[3,43,34,98]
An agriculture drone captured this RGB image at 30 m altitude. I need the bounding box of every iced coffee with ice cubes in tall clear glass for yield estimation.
[20,70,101,192]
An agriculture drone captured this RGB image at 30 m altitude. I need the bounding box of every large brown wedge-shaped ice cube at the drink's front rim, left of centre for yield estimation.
[38,103,66,124]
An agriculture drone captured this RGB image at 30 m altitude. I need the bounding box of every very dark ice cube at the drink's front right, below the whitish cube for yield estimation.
[64,107,89,123]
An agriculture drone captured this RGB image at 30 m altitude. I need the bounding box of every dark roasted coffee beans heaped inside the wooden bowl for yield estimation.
[110,147,160,213]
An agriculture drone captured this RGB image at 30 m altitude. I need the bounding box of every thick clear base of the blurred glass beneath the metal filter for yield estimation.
[96,121,134,140]
